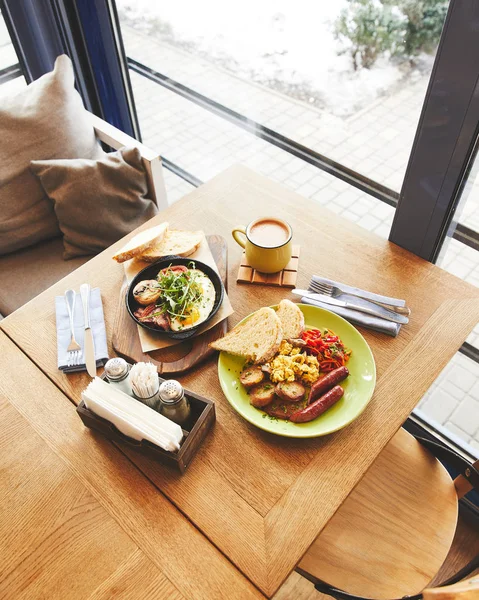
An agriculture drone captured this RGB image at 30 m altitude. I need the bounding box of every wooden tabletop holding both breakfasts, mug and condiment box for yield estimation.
[0,167,479,597]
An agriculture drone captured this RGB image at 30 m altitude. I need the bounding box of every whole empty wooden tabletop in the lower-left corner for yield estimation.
[0,332,263,600]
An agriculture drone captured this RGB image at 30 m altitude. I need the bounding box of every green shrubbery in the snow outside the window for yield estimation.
[335,0,448,70]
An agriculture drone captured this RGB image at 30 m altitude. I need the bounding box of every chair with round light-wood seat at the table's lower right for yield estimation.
[298,429,479,599]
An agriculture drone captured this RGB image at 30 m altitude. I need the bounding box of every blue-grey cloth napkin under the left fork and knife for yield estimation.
[55,288,108,373]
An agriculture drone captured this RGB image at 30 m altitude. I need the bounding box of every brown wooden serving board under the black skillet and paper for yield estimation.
[112,235,228,374]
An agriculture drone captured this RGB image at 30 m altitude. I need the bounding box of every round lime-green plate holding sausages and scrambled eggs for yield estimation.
[218,304,376,438]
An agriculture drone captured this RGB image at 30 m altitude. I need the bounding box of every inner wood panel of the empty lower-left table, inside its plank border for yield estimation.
[0,394,139,599]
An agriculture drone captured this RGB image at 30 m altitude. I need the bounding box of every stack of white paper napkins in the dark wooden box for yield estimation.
[82,377,183,452]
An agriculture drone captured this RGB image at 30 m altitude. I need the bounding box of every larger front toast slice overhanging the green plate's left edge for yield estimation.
[210,307,283,364]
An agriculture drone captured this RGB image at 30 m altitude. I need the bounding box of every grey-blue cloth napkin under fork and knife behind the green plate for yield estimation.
[301,275,408,337]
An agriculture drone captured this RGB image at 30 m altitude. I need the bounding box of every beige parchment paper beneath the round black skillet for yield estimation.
[123,234,234,352]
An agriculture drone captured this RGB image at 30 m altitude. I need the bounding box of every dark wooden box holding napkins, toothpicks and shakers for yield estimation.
[77,377,216,473]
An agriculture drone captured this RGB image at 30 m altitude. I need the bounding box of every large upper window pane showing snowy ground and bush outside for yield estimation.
[117,0,448,191]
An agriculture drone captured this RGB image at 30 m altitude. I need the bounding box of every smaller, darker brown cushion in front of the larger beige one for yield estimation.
[31,148,158,259]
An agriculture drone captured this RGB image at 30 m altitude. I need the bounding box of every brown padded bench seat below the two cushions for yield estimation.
[0,237,88,317]
